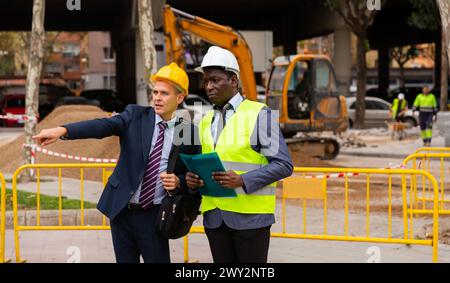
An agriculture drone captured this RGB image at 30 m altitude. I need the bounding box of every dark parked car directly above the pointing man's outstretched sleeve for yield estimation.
[80,89,127,112]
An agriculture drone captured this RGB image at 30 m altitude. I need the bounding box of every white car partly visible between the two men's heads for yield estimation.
[177,94,213,125]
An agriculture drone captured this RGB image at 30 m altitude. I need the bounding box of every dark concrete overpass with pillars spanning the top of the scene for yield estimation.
[0,0,440,103]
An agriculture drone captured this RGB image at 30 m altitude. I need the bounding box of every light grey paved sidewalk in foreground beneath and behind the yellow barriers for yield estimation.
[6,200,450,263]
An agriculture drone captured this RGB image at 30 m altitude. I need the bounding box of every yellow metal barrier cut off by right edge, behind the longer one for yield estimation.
[403,152,450,215]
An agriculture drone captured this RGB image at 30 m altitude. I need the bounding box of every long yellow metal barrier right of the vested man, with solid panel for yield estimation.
[184,168,439,262]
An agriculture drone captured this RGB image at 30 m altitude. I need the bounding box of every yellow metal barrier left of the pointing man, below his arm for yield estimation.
[12,164,115,262]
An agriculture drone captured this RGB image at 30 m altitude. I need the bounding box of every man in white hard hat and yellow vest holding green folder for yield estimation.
[186,46,293,263]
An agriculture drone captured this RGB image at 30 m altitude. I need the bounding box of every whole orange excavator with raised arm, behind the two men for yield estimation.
[163,5,348,159]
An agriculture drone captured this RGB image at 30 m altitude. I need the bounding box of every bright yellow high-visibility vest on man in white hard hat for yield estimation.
[199,100,275,214]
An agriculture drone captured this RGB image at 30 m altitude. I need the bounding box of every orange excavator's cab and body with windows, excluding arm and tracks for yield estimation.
[266,55,347,136]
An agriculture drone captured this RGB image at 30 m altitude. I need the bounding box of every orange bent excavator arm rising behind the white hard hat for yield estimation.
[163,5,257,100]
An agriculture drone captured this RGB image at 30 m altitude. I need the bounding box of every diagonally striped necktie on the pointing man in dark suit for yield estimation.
[139,122,167,209]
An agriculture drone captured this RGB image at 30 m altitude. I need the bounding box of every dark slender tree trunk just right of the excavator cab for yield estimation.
[354,37,367,129]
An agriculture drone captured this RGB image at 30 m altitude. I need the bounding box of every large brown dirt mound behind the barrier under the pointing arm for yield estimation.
[0,105,120,180]
